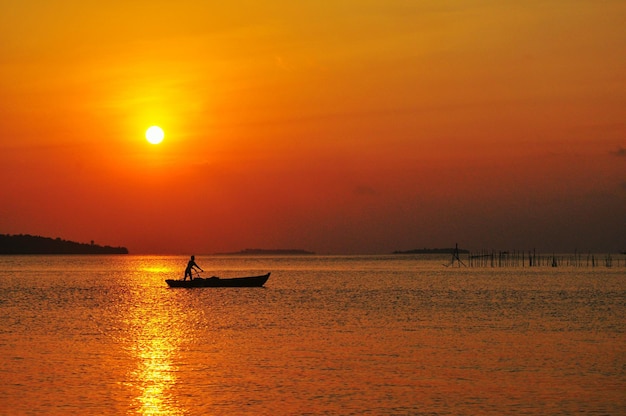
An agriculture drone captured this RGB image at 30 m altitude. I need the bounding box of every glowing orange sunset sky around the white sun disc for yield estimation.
[0,0,626,254]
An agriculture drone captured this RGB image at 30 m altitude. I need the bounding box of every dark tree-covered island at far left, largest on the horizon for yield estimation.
[0,234,128,255]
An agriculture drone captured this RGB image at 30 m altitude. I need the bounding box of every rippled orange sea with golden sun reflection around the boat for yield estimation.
[0,255,626,415]
